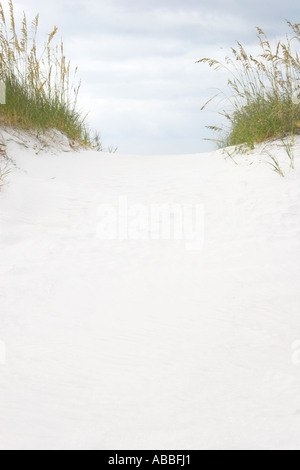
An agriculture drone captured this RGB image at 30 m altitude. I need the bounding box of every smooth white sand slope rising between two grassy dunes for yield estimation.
[0,130,300,450]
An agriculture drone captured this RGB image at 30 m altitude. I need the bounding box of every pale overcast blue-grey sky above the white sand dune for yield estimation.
[9,0,300,154]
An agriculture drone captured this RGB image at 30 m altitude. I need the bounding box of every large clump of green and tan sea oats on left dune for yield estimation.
[0,0,96,145]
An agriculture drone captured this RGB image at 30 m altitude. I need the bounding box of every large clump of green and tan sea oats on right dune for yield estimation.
[197,21,300,149]
